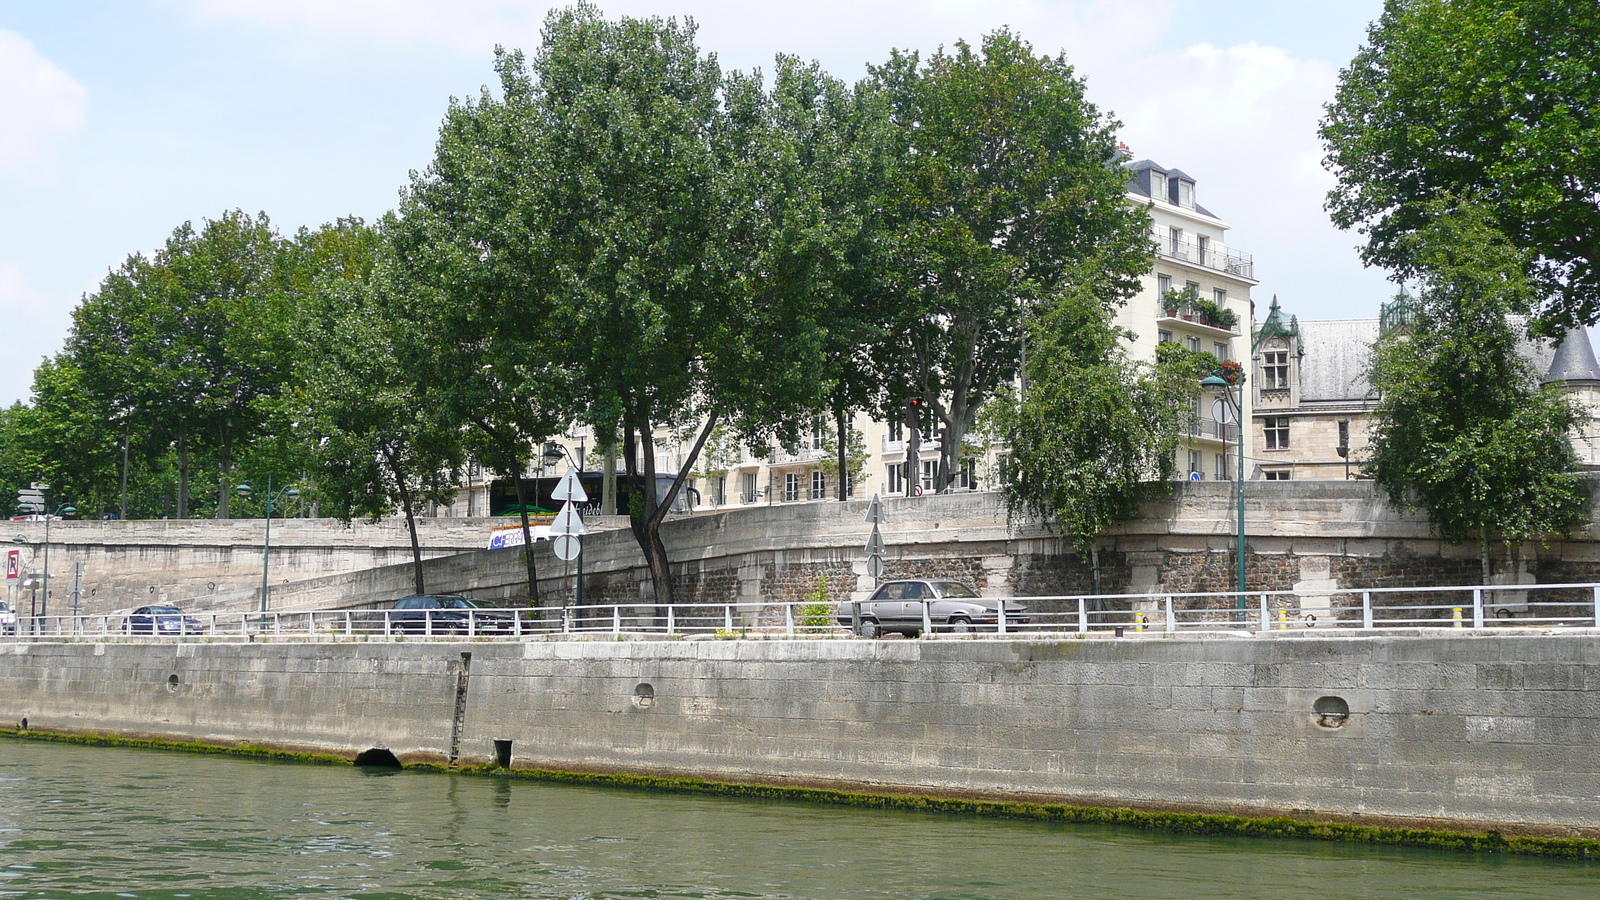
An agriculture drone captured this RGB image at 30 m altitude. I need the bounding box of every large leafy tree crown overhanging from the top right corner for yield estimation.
[1322,0,1600,333]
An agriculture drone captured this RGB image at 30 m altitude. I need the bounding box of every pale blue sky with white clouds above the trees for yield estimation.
[0,0,1395,405]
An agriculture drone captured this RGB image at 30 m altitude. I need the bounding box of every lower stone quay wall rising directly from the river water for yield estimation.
[0,631,1600,838]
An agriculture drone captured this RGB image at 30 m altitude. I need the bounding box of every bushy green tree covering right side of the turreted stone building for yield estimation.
[1366,200,1589,580]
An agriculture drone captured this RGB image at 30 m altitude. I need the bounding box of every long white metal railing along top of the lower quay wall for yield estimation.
[9,583,1600,641]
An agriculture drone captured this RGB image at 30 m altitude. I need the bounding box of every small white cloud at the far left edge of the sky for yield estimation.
[0,30,88,175]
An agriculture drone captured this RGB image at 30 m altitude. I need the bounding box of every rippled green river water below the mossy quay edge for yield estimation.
[0,740,1600,900]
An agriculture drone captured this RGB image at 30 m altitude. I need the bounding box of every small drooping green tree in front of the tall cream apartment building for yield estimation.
[984,290,1196,559]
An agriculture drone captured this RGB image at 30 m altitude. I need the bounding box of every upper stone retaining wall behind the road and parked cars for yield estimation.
[14,482,1600,613]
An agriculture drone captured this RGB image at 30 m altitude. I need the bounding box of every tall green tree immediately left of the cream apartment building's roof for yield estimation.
[872,30,1152,490]
